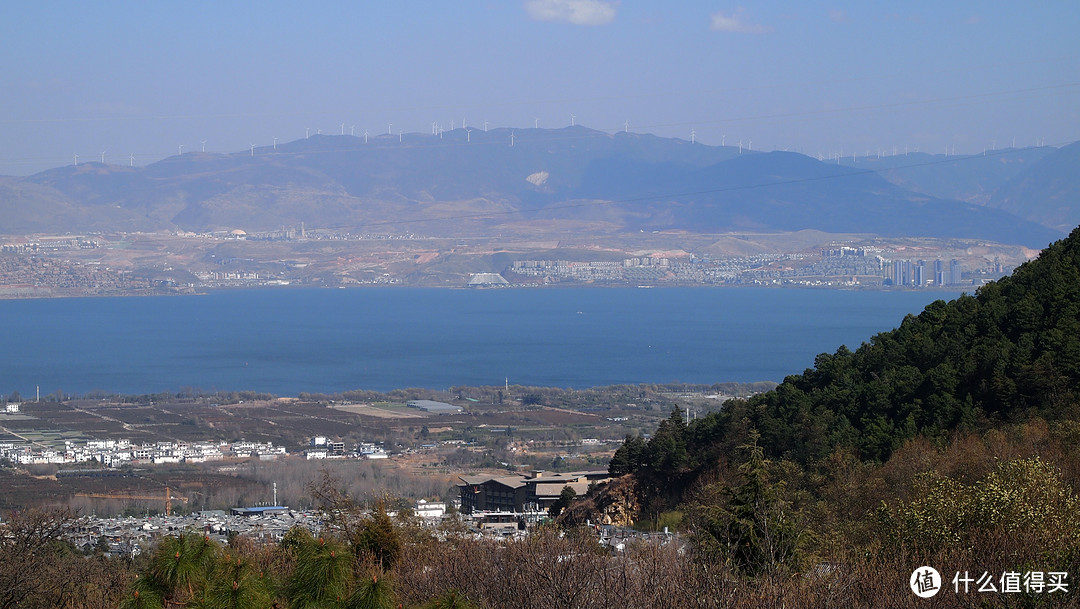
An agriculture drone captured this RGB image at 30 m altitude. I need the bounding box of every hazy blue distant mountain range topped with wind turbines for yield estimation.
[0,126,1080,247]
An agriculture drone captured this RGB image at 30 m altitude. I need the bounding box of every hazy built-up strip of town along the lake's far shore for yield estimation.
[0,225,1036,298]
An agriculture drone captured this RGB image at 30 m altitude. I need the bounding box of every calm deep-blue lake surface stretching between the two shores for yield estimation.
[0,288,958,397]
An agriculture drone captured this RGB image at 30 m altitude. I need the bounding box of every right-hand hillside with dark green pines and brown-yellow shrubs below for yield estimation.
[600,229,1080,600]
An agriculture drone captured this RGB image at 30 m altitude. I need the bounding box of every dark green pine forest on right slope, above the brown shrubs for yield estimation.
[612,223,1080,476]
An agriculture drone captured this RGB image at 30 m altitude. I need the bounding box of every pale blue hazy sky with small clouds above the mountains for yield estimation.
[0,0,1080,175]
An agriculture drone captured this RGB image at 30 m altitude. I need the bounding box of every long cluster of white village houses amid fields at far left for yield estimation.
[0,439,285,468]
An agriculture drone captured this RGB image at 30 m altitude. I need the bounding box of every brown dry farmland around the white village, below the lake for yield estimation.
[0,388,699,514]
